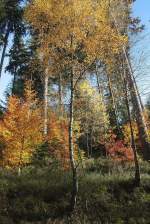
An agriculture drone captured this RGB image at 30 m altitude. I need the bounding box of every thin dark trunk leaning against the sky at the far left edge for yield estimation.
[0,24,10,78]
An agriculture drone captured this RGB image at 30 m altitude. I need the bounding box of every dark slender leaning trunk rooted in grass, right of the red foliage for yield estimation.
[122,64,141,186]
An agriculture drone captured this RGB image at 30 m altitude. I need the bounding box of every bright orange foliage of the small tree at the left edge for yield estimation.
[0,85,43,167]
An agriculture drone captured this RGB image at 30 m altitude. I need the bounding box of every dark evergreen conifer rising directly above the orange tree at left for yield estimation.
[6,35,43,98]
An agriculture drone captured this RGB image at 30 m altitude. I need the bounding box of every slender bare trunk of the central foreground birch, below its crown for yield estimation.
[69,72,78,211]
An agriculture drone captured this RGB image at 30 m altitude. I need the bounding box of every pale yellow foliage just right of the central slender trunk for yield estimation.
[74,80,109,149]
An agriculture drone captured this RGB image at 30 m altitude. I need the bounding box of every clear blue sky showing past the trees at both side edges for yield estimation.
[0,0,150,101]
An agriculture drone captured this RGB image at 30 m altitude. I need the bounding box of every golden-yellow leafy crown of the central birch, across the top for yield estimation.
[25,0,126,69]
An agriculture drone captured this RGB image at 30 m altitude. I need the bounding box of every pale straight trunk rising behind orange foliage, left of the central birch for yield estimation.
[44,70,49,136]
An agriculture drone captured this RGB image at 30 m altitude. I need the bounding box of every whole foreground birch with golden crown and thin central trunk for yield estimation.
[26,0,126,210]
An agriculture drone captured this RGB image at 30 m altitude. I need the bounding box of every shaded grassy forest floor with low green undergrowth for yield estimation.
[0,159,150,224]
